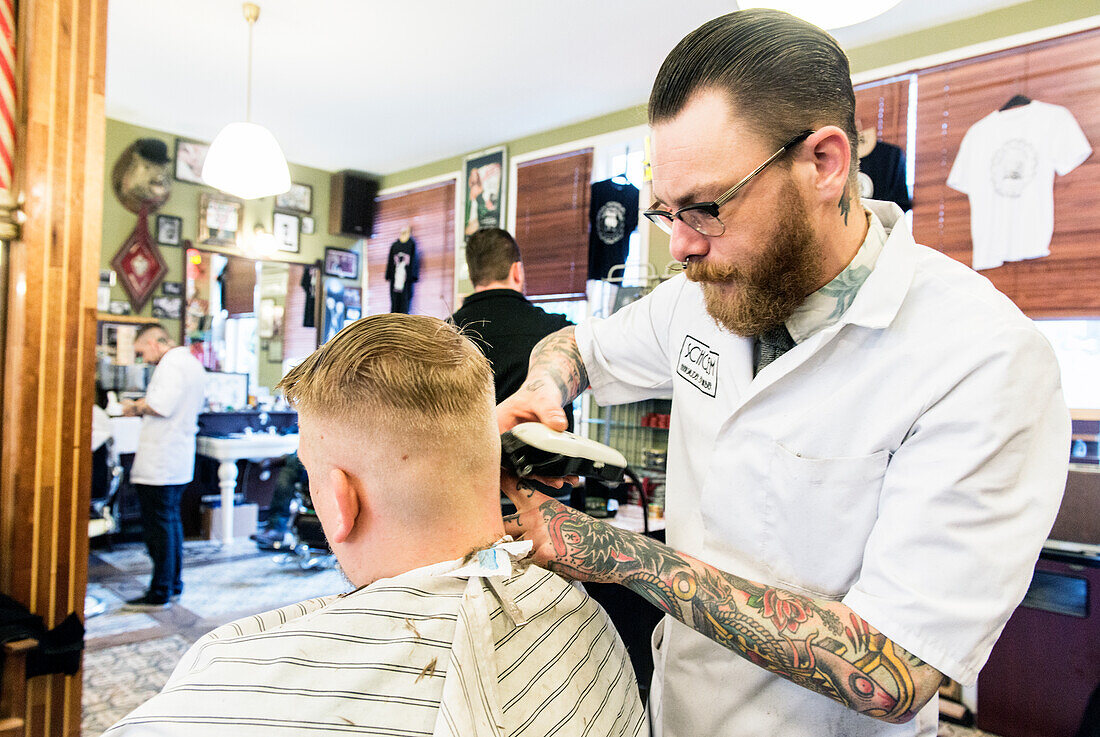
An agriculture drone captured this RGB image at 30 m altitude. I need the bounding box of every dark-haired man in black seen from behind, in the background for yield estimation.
[451,228,573,428]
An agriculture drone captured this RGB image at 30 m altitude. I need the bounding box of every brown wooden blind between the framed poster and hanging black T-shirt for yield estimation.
[514,149,592,300]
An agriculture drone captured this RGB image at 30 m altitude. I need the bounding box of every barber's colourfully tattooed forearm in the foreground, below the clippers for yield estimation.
[530,502,941,722]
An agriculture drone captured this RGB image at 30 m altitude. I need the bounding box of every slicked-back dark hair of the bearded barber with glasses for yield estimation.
[649,9,859,188]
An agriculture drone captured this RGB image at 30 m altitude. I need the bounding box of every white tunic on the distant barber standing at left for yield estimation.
[130,348,206,486]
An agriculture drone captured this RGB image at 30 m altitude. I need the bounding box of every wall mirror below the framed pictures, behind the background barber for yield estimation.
[183,249,320,398]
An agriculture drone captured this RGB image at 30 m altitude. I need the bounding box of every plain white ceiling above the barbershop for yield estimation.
[107,0,1022,174]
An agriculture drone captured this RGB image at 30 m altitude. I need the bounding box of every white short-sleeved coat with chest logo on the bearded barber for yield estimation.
[576,202,1069,737]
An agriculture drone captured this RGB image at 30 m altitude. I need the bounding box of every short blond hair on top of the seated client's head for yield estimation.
[276,314,496,451]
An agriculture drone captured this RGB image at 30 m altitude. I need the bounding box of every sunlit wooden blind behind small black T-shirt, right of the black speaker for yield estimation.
[364,179,454,318]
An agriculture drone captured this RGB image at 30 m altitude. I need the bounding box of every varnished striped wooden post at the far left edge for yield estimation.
[0,0,113,737]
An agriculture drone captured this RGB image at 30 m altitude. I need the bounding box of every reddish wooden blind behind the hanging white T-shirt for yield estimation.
[913,31,1100,317]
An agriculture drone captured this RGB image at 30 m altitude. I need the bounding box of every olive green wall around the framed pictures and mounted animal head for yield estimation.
[99,119,356,337]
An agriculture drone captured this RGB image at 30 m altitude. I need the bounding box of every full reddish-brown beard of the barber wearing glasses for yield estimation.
[684,183,821,336]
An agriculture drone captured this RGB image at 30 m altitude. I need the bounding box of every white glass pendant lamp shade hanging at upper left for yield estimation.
[202,122,290,199]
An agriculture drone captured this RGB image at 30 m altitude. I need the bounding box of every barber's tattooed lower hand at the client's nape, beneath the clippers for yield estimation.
[501,473,614,582]
